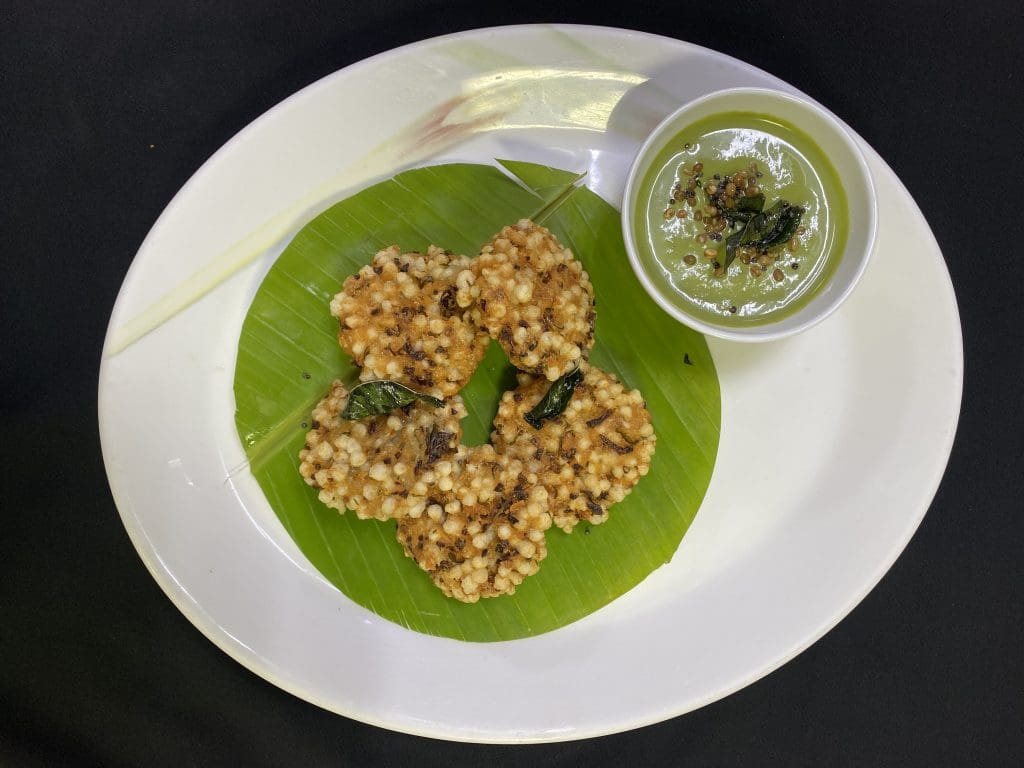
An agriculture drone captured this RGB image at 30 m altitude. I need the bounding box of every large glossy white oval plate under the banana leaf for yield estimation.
[99,27,963,742]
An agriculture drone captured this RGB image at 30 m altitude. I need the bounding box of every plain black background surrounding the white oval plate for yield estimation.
[0,0,1024,766]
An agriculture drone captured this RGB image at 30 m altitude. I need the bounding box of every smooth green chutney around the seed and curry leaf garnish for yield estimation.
[633,112,849,326]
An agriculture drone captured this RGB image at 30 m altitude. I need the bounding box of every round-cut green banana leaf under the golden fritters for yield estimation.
[234,161,721,641]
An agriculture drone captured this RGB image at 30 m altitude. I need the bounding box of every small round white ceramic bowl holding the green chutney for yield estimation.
[623,88,878,341]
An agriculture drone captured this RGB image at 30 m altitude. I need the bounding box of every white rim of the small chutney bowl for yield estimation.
[621,87,878,342]
